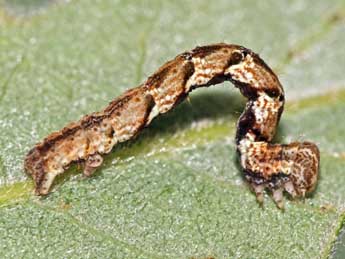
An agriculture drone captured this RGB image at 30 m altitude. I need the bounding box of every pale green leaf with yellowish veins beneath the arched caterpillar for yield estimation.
[0,0,345,258]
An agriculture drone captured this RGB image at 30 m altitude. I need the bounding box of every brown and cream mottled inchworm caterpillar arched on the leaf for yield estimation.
[24,43,320,208]
